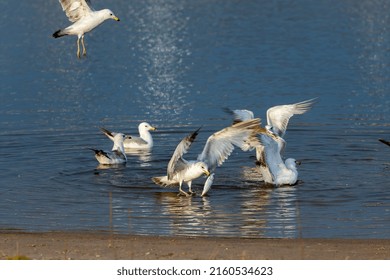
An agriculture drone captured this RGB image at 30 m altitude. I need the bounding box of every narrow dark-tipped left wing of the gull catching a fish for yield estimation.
[167,128,200,180]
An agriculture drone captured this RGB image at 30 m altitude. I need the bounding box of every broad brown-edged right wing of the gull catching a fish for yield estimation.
[198,119,260,170]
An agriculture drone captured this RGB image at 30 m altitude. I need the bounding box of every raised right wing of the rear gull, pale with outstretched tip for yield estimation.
[267,98,316,137]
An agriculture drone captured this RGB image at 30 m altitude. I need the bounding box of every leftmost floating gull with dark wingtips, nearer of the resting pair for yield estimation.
[91,133,127,165]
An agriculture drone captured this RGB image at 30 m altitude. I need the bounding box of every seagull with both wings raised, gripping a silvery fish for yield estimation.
[152,119,260,196]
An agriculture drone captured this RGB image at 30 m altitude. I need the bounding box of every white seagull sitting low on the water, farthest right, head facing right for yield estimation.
[260,133,300,186]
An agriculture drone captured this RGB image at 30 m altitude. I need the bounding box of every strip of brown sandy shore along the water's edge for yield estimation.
[0,232,390,260]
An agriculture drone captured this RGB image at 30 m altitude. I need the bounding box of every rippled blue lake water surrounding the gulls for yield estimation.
[0,0,390,238]
